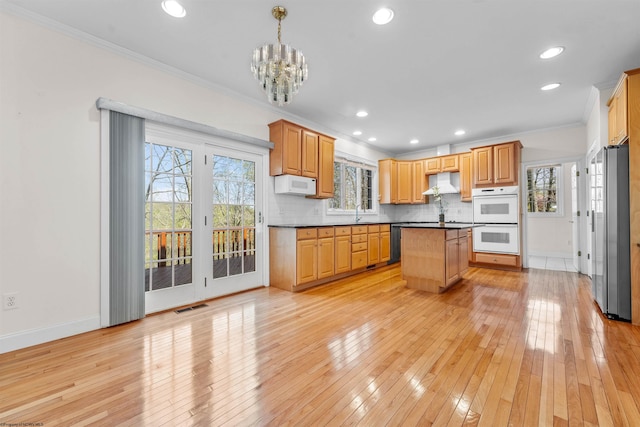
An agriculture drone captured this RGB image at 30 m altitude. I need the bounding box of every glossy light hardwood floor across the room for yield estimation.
[0,265,640,427]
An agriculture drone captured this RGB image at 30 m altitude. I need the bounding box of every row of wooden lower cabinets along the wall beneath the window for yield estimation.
[269,224,391,291]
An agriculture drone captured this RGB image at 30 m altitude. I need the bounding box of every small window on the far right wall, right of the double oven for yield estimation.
[527,165,562,214]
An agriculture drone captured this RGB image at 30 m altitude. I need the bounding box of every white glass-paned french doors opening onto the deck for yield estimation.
[144,128,264,313]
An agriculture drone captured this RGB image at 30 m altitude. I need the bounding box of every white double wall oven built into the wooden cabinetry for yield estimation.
[472,186,520,255]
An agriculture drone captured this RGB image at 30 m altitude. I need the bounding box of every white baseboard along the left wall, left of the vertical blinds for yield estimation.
[0,316,100,354]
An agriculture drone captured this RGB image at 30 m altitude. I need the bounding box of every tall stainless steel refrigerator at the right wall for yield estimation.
[590,145,631,320]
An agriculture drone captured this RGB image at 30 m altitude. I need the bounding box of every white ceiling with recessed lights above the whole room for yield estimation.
[3,0,640,154]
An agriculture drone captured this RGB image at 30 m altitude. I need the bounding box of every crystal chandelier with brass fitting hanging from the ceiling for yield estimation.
[251,6,308,106]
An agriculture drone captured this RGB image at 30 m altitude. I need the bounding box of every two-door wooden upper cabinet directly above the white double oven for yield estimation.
[471,141,522,188]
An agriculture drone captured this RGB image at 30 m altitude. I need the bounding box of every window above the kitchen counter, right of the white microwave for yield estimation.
[328,160,374,212]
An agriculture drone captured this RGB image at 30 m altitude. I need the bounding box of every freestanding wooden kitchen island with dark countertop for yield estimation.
[401,223,474,293]
